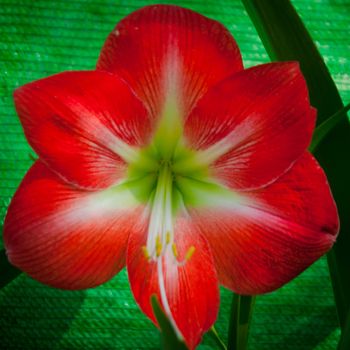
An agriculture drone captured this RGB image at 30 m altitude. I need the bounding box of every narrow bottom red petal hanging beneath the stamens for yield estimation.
[127,218,219,348]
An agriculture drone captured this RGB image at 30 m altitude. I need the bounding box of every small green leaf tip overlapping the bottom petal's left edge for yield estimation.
[151,295,188,350]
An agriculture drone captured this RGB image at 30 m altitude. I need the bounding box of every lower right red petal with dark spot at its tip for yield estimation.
[192,153,339,295]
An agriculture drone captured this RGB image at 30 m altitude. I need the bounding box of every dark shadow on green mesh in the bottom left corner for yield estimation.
[0,274,85,349]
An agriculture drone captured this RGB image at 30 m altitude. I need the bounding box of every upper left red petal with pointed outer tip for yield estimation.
[14,71,150,188]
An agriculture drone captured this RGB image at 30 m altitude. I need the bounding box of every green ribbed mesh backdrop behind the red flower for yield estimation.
[0,0,350,350]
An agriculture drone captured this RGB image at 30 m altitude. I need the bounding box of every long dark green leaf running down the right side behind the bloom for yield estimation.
[242,0,350,328]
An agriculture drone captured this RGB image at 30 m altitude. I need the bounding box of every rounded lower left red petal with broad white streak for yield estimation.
[4,162,145,289]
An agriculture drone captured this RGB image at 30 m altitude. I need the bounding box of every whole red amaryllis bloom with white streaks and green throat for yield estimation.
[4,5,338,348]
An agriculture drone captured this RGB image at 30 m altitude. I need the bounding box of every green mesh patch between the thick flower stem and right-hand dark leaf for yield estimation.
[249,258,340,350]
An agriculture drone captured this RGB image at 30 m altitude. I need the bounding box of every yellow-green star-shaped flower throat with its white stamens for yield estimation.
[119,93,239,264]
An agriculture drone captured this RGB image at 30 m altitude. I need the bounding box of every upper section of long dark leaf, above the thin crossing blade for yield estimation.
[242,0,343,124]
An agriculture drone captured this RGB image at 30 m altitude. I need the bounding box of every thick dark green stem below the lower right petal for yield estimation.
[227,294,255,350]
